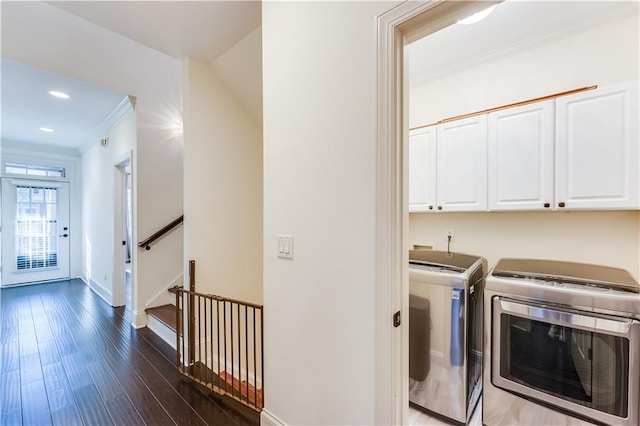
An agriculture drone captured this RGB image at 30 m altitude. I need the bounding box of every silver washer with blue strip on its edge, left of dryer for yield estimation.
[409,250,487,423]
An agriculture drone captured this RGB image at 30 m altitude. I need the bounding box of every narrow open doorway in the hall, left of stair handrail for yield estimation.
[113,156,134,309]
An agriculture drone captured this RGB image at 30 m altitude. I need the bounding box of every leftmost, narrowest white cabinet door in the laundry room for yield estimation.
[409,126,436,212]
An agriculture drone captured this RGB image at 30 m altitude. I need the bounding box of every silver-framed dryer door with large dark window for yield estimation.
[491,298,639,422]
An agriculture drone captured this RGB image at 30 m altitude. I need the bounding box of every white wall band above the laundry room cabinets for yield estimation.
[409,13,640,128]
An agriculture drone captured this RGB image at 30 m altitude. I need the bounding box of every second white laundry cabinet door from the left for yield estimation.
[436,114,487,212]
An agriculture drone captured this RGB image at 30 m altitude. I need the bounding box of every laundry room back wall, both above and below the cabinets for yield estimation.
[409,10,640,279]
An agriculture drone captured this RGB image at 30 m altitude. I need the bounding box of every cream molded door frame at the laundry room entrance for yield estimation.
[374,0,502,424]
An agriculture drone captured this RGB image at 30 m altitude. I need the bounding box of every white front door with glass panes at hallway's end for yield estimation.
[2,178,70,286]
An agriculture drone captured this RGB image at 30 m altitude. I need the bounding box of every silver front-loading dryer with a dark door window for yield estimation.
[482,259,640,426]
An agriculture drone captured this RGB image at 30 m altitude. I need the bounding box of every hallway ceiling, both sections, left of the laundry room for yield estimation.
[0,1,262,152]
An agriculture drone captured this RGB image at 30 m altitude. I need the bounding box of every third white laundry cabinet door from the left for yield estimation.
[488,100,554,210]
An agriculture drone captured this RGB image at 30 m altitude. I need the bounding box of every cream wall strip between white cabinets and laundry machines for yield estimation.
[409,211,640,280]
